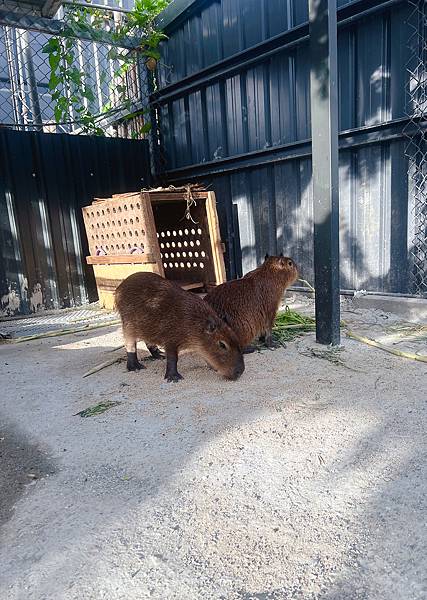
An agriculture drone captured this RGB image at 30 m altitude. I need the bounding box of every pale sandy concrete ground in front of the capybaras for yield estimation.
[0,300,427,600]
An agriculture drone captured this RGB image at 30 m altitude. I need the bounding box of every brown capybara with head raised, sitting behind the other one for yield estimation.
[205,254,298,352]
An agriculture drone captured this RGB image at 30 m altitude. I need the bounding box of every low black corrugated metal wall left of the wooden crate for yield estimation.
[0,129,150,316]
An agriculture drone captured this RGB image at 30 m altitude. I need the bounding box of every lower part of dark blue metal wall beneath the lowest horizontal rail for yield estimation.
[173,140,408,293]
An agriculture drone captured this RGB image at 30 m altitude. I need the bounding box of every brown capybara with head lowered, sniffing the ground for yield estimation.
[115,273,245,381]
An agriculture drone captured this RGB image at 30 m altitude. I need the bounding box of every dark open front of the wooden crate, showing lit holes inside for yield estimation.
[152,198,215,289]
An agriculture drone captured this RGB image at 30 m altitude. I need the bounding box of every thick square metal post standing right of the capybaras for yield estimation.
[309,0,340,345]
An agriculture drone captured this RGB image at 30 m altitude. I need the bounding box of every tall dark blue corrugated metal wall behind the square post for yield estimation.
[155,0,412,292]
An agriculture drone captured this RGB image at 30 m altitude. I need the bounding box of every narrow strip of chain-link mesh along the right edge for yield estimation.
[405,0,427,297]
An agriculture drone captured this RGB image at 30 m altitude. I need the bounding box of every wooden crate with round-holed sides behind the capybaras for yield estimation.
[83,190,225,309]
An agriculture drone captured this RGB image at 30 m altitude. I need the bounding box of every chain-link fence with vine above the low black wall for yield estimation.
[0,1,154,138]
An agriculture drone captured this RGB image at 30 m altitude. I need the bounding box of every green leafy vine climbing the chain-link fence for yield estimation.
[43,0,170,135]
